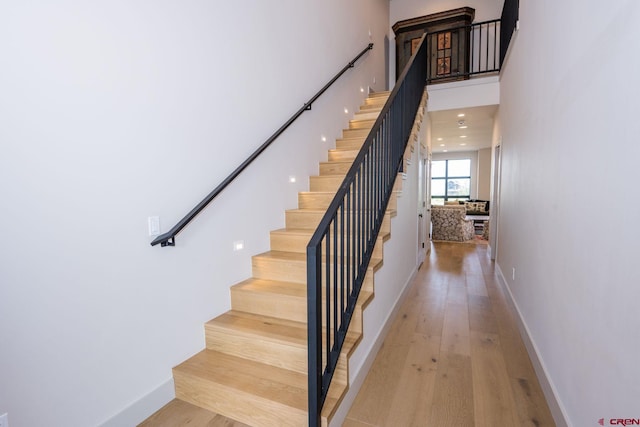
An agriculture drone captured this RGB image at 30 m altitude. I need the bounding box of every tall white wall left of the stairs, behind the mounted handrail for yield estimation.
[0,0,389,426]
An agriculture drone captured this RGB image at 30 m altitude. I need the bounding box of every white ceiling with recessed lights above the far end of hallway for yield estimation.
[429,105,498,153]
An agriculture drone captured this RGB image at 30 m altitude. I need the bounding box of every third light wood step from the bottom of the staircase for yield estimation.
[231,275,373,324]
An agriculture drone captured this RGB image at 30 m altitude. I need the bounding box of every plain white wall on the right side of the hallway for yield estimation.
[497,0,640,426]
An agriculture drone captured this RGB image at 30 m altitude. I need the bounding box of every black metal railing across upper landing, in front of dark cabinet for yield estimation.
[427,19,502,83]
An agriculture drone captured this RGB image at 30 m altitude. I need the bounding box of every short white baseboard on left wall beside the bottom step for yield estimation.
[100,378,176,427]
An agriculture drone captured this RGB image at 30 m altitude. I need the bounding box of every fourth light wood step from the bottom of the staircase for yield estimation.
[251,251,382,285]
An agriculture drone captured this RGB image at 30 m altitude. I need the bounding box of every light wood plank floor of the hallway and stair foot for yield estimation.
[141,242,555,427]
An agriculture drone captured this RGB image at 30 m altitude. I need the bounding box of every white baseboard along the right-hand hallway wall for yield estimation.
[495,262,572,427]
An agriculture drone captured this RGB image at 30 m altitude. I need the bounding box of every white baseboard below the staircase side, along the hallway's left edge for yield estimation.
[329,267,418,427]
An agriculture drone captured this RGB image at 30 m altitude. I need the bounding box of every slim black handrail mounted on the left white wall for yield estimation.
[151,43,373,247]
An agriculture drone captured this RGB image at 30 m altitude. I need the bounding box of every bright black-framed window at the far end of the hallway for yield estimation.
[431,159,471,205]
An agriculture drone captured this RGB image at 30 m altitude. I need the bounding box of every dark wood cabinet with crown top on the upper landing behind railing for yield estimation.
[392,7,475,82]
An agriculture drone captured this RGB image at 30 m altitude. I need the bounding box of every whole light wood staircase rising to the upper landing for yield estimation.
[173,93,402,426]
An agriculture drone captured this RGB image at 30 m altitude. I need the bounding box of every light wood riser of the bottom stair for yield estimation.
[173,370,308,427]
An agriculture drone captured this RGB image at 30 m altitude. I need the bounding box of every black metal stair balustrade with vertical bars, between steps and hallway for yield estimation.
[307,37,427,426]
